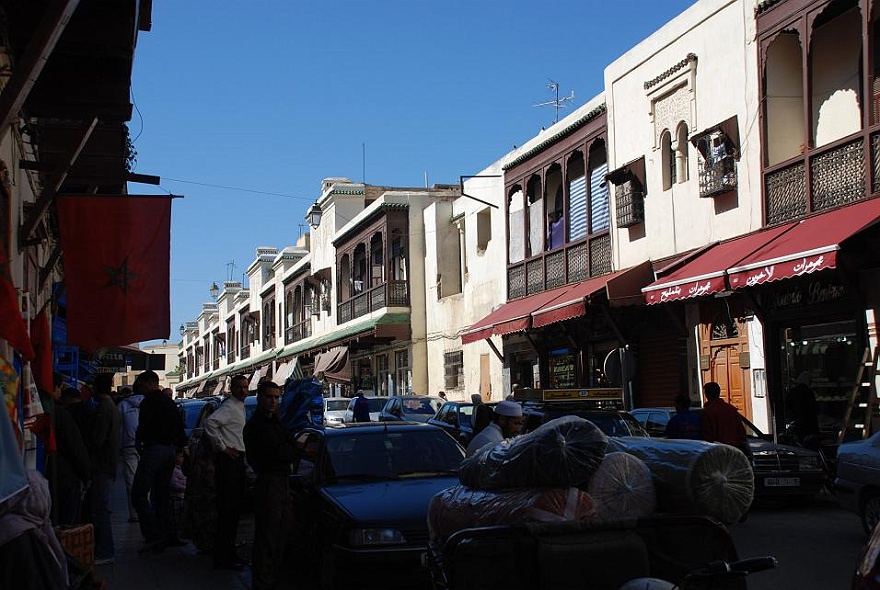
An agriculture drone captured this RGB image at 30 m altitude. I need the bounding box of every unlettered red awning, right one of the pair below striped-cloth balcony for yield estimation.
[532,262,651,328]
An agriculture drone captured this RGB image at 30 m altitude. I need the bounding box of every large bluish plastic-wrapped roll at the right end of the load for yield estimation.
[608,437,755,524]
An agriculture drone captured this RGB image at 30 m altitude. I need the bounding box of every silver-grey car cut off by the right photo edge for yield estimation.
[834,432,880,533]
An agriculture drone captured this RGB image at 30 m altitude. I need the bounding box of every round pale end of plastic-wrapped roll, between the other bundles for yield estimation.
[587,453,657,521]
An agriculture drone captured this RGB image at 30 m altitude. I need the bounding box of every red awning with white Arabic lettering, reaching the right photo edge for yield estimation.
[727,199,880,289]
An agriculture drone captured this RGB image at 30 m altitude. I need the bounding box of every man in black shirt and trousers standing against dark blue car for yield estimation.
[244,381,299,590]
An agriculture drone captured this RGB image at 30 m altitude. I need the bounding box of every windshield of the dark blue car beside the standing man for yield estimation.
[327,429,464,481]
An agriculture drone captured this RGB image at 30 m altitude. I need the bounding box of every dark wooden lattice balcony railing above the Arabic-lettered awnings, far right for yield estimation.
[764,132,868,225]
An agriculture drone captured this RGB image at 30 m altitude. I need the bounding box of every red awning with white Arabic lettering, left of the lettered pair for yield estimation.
[642,223,796,304]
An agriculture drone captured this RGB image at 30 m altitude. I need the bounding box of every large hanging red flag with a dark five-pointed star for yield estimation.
[56,195,171,352]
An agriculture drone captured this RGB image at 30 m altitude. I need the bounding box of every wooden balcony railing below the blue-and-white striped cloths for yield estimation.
[507,234,611,300]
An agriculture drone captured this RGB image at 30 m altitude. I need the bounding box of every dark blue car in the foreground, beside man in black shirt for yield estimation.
[291,422,464,588]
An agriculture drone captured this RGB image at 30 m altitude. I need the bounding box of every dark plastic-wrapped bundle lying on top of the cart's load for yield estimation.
[458,416,608,490]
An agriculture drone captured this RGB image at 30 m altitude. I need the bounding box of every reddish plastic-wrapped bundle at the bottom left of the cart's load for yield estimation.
[428,485,598,547]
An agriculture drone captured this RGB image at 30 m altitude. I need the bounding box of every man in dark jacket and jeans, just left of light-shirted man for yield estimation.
[89,373,121,565]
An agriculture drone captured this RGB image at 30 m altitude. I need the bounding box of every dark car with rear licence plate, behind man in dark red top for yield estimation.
[630,408,828,502]
